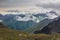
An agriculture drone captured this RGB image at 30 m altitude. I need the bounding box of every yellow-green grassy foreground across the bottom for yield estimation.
[0,28,60,40]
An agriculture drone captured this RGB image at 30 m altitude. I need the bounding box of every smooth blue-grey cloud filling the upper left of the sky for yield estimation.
[0,0,34,7]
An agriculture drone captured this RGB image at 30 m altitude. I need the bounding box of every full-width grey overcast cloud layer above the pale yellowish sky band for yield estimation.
[0,0,60,11]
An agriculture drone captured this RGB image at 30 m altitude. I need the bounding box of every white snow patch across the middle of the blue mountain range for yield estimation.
[15,15,40,23]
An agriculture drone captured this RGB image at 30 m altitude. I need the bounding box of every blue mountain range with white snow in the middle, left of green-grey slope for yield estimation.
[0,14,47,30]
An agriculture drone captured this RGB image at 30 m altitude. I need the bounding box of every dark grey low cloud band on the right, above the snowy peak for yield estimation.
[36,3,60,10]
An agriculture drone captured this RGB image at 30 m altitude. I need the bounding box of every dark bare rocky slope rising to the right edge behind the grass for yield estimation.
[34,18,60,34]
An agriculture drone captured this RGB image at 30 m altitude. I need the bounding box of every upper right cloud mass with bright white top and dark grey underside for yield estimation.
[36,0,60,10]
